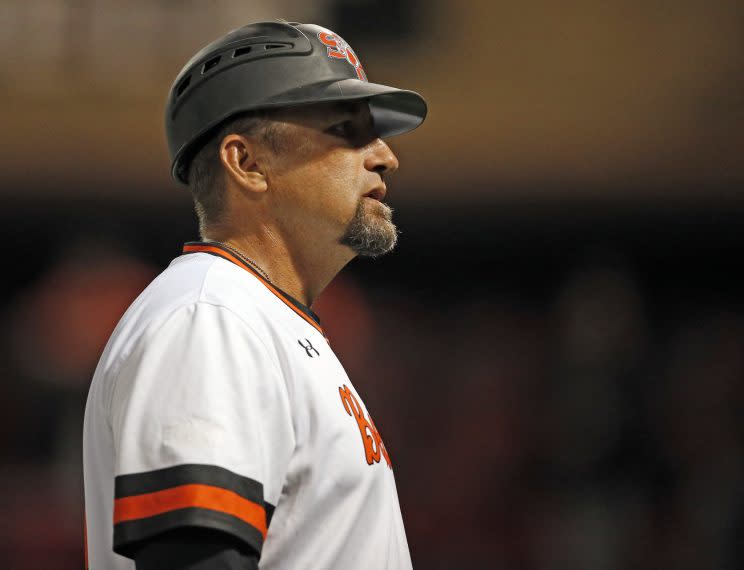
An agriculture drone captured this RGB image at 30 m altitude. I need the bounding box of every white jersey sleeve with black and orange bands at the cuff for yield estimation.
[110,303,294,556]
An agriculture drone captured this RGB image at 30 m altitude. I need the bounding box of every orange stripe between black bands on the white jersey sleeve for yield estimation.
[114,484,267,538]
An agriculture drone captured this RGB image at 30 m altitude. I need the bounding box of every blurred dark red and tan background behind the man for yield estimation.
[0,0,744,570]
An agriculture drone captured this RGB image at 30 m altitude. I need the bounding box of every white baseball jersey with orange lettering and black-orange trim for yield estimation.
[83,243,411,570]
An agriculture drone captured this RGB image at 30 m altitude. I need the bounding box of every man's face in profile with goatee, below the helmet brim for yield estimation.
[265,102,398,257]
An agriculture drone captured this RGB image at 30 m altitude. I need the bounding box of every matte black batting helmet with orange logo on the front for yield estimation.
[165,22,426,184]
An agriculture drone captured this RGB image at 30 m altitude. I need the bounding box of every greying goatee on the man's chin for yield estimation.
[341,199,398,257]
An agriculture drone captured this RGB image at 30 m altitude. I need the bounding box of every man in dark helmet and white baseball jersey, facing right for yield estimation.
[84,22,426,570]
